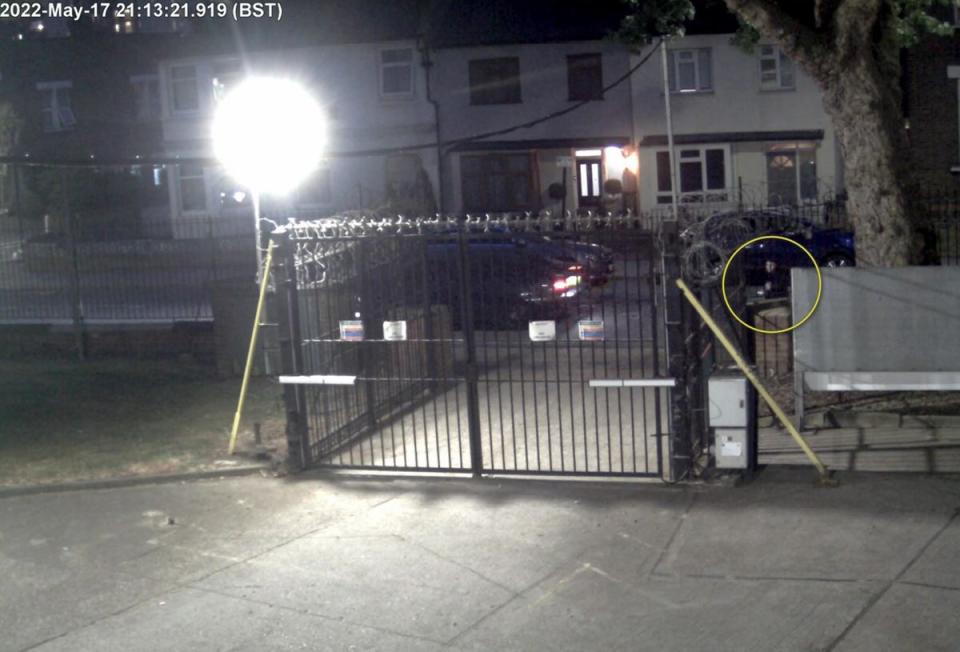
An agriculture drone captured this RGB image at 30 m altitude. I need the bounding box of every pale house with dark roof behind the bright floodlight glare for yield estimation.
[159,1,437,235]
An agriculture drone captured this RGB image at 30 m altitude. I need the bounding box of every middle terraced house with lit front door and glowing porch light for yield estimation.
[427,2,636,213]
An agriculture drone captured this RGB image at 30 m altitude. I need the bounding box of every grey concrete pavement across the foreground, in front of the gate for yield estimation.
[0,469,960,651]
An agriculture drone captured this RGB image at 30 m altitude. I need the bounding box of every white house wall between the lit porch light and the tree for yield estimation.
[631,35,841,209]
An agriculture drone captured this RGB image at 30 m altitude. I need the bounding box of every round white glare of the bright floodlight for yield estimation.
[213,77,324,195]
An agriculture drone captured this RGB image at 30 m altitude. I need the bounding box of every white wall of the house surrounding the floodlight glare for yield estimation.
[159,41,437,237]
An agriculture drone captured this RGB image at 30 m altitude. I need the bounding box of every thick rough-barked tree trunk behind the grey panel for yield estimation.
[726,0,919,267]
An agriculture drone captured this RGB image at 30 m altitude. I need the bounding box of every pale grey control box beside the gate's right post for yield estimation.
[707,374,757,469]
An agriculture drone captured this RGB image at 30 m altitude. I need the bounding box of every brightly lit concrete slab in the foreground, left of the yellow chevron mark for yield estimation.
[190,535,514,643]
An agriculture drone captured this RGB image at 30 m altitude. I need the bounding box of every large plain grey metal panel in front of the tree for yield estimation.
[792,267,960,373]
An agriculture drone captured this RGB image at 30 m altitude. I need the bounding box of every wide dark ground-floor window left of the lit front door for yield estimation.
[460,153,532,211]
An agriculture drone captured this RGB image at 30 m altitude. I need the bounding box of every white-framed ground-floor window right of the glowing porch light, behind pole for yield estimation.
[657,147,730,204]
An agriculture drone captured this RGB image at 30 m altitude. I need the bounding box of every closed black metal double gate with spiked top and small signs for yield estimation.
[273,216,672,477]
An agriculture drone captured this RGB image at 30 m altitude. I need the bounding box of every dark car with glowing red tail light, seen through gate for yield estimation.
[427,234,583,329]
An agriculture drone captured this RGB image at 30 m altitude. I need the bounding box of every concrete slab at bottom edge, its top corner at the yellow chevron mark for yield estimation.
[455,562,877,651]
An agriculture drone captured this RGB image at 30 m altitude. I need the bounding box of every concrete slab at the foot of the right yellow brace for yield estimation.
[657,474,958,580]
